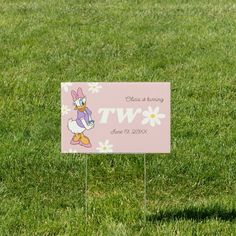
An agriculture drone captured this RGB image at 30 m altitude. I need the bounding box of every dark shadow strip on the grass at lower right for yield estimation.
[147,206,236,223]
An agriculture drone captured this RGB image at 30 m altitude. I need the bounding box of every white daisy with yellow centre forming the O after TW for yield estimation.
[142,107,166,127]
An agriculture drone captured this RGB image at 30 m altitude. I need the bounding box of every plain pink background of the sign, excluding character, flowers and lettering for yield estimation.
[61,82,170,153]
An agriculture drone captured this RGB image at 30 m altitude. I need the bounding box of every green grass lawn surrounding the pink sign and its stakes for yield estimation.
[0,0,236,235]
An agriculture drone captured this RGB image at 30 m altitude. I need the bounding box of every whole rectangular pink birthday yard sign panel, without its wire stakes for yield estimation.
[61,82,170,153]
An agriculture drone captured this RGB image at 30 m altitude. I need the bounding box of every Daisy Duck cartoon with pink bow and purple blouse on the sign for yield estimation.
[68,88,94,148]
